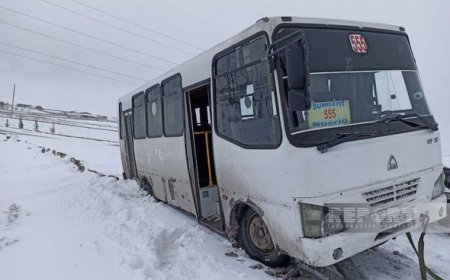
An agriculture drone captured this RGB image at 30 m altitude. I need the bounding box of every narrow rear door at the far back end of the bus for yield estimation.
[122,110,137,179]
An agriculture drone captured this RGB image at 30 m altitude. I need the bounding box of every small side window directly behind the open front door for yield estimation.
[162,75,183,137]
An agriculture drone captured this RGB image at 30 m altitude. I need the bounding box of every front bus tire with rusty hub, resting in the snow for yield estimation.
[239,208,291,267]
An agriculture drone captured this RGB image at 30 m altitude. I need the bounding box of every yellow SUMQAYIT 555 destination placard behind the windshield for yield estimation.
[308,100,352,128]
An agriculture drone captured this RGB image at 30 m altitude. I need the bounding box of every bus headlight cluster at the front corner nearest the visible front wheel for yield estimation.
[300,203,345,238]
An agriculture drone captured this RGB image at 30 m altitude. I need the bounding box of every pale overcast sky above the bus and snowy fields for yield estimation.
[0,0,450,138]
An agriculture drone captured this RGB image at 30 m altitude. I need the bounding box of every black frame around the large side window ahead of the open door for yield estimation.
[211,31,284,150]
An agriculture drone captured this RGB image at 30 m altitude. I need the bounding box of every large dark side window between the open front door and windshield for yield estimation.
[214,36,281,148]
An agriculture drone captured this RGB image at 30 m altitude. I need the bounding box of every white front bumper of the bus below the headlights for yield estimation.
[300,195,450,267]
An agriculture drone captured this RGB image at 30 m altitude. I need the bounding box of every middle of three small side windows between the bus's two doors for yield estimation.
[145,85,162,138]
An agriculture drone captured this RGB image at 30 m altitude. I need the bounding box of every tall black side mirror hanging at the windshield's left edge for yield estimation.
[286,39,311,111]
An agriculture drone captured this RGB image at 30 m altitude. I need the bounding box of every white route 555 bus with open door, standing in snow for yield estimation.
[118,17,446,267]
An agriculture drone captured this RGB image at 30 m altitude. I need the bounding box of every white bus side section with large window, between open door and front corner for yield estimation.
[212,32,298,248]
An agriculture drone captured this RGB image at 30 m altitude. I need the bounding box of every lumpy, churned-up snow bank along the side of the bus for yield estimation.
[66,178,270,279]
